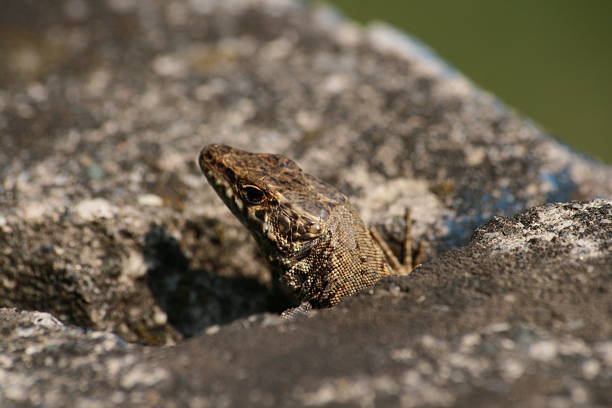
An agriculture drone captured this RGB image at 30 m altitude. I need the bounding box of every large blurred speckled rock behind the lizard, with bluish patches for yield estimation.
[0,0,612,344]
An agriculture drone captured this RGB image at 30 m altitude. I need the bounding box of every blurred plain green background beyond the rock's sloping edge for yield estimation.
[314,0,612,163]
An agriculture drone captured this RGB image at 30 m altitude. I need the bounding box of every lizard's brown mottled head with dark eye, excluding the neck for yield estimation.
[198,144,346,261]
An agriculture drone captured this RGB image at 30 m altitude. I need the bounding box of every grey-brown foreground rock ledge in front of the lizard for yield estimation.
[0,200,612,407]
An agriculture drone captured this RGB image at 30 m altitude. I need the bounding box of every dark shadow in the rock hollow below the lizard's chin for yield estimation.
[143,224,271,337]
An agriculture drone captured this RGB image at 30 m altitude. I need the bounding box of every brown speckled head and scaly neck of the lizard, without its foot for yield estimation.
[199,144,392,307]
